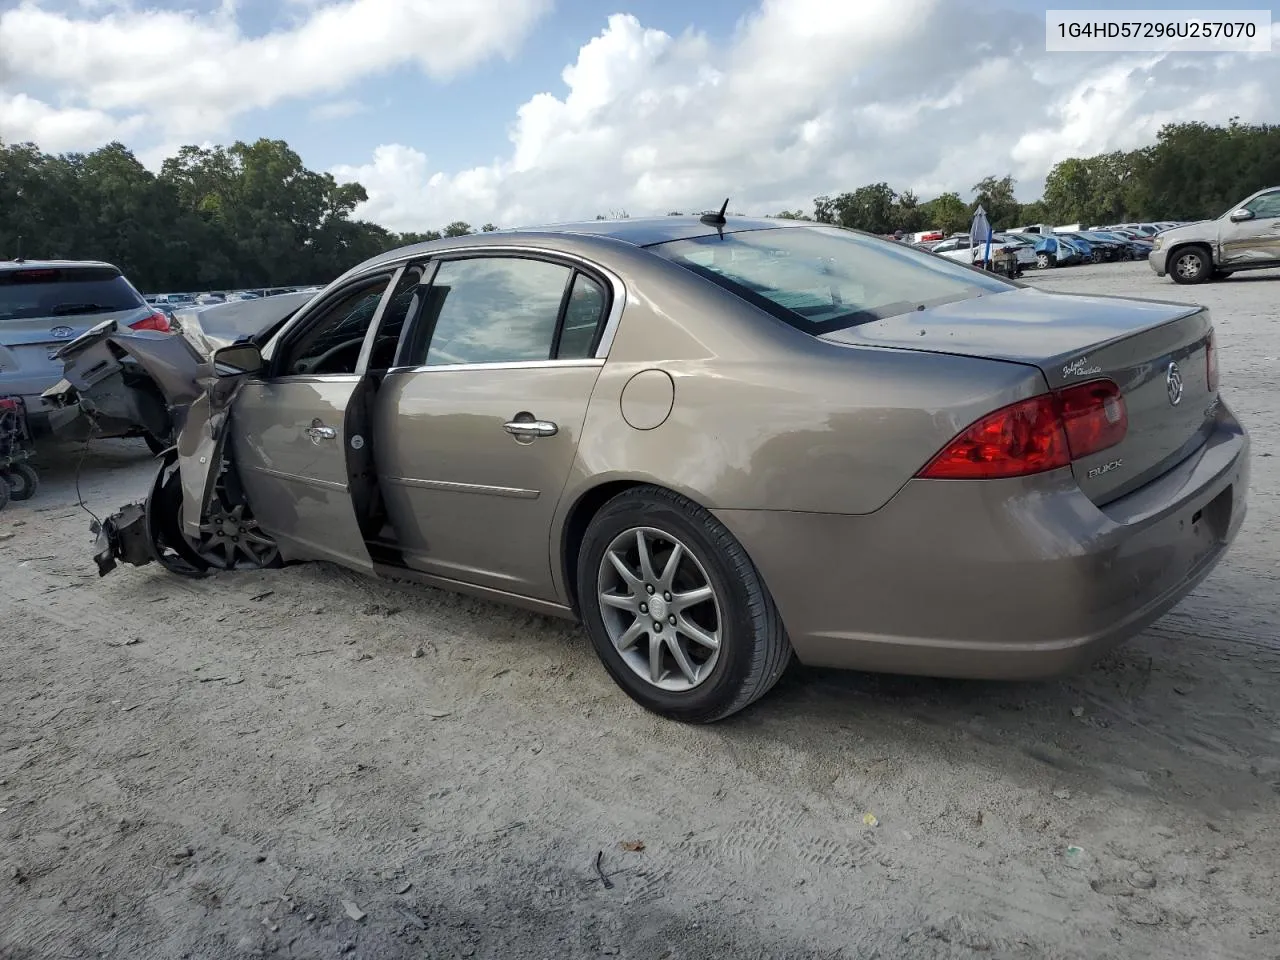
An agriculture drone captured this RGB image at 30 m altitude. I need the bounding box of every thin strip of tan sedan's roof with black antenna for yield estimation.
[344,216,793,275]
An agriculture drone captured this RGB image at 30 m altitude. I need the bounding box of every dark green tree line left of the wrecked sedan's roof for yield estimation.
[0,140,497,291]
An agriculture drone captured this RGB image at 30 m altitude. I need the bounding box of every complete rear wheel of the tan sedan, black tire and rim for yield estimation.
[577,486,792,723]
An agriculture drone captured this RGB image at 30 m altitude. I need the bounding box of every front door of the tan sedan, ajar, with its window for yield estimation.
[230,269,397,571]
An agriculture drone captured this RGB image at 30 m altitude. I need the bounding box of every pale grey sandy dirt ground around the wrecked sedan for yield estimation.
[0,264,1280,960]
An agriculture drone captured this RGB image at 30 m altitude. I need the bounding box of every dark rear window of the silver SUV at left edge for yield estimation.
[0,268,145,320]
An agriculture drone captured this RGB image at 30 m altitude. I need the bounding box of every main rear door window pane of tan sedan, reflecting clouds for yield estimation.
[419,257,571,366]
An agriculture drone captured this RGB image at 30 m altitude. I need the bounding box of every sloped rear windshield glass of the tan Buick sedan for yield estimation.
[650,227,1012,334]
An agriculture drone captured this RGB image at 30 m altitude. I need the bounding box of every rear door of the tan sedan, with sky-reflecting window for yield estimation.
[374,252,621,602]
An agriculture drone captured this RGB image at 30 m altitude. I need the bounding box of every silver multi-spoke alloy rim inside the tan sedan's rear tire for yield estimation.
[596,527,723,692]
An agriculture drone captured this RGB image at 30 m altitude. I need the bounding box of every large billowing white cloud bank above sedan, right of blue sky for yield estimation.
[333,0,1280,230]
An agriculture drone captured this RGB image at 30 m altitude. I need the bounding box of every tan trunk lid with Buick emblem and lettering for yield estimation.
[824,288,1217,504]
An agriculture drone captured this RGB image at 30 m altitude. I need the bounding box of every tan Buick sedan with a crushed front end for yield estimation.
[50,215,1248,722]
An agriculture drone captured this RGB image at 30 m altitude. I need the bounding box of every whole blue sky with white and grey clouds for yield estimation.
[0,0,1280,229]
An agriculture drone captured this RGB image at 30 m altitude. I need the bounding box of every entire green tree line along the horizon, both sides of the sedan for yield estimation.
[0,118,1280,291]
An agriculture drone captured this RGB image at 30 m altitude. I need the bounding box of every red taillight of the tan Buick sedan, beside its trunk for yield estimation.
[918,380,1129,480]
